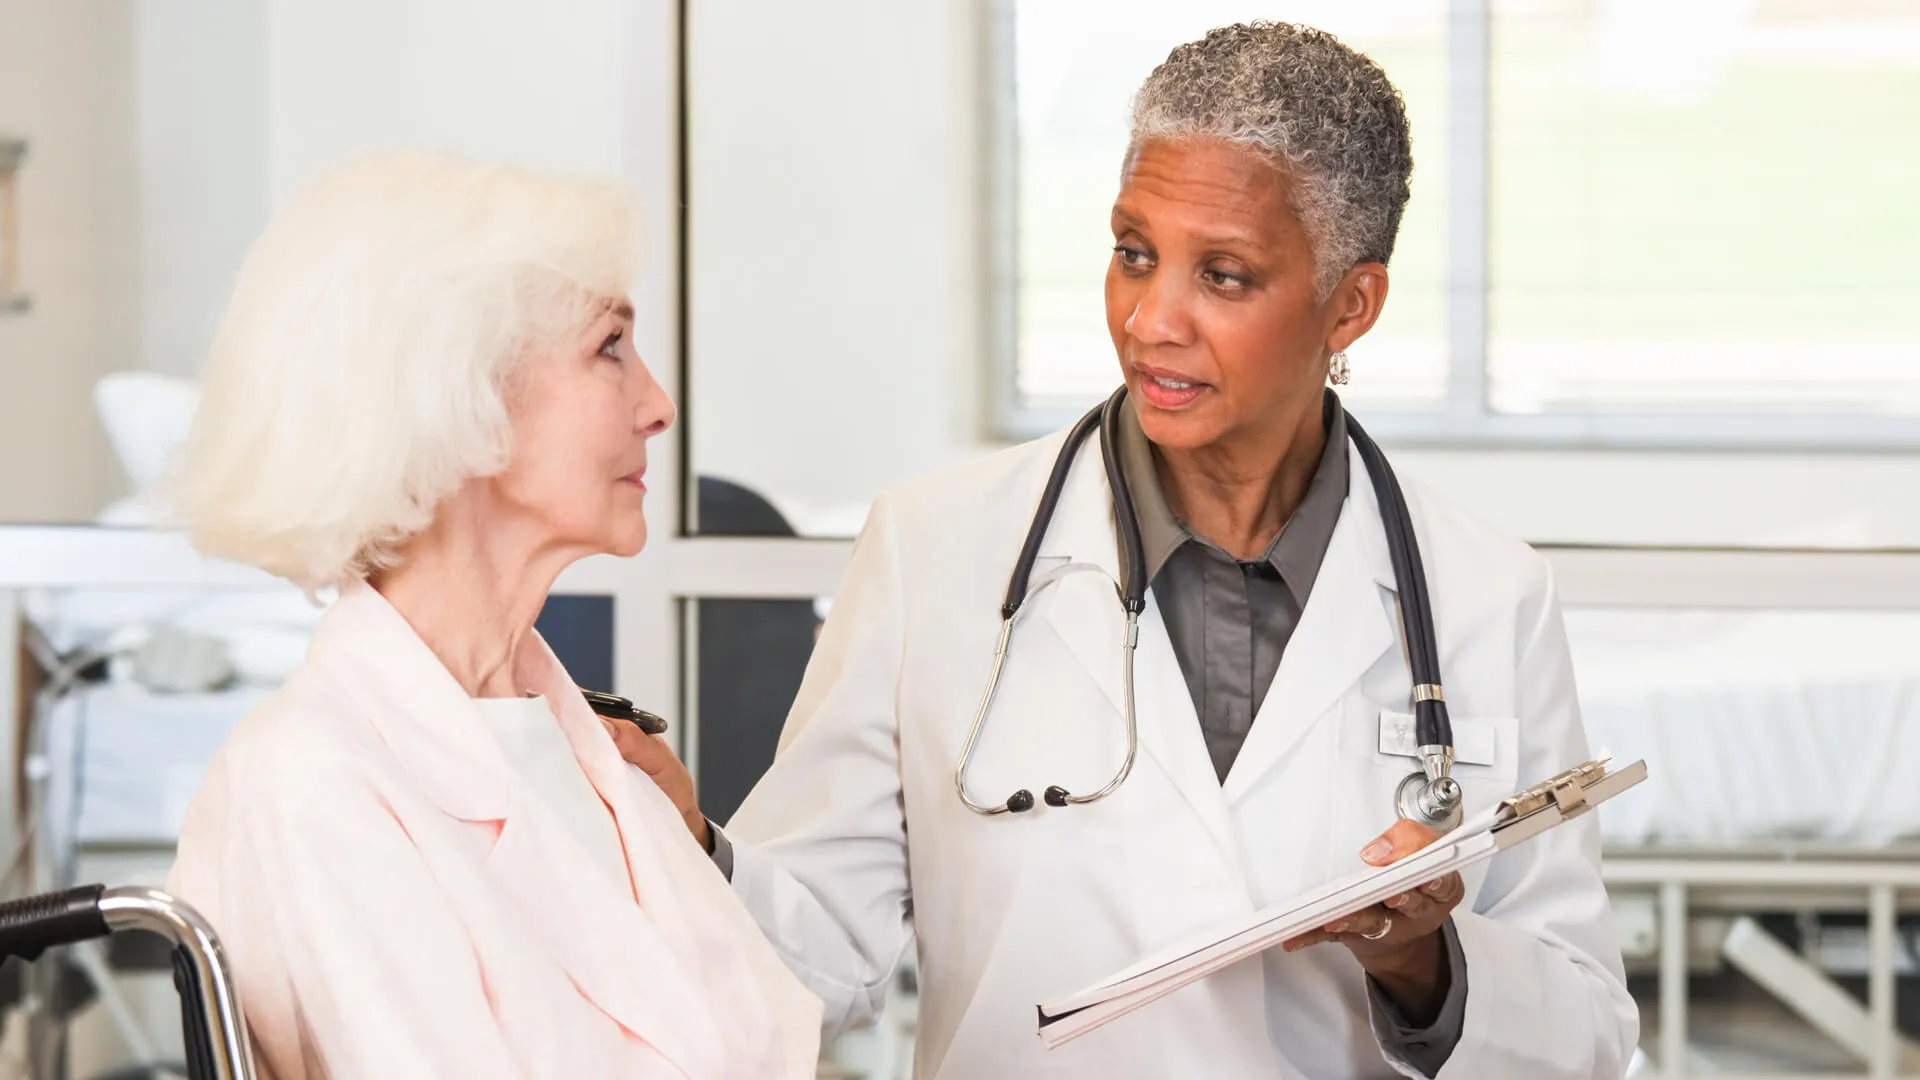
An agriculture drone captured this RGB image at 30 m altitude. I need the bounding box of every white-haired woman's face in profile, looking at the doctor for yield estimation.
[493,302,674,555]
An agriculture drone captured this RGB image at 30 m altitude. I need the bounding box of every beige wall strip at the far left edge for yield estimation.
[0,0,138,521]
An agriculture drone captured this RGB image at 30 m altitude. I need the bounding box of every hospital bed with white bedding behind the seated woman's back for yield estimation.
[0,527,301,1078]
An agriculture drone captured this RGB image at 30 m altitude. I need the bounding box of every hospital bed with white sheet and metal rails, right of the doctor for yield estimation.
[1567,591,1920,1078]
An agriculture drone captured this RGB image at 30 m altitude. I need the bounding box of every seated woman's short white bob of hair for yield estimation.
[173,152,639,592]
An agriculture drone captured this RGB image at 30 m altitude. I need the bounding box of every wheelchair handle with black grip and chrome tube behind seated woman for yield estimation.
[0,886,253,1080]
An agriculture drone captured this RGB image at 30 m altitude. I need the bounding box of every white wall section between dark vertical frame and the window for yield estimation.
[687,0,987,530]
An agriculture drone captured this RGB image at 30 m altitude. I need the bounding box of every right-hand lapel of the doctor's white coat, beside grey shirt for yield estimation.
[1225,441,1400,801]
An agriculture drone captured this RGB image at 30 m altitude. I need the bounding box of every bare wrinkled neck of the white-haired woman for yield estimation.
[369,486,580,698]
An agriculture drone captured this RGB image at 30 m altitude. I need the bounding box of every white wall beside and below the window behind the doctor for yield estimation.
[687,0,1920,546]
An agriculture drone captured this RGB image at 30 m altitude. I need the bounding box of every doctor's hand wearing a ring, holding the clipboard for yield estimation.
[1286,819,1467,1022]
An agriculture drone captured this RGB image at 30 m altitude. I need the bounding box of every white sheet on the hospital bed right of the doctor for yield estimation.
[1567,611,1920,847]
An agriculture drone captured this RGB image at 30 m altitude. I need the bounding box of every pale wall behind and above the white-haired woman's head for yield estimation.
[0,0,652,521]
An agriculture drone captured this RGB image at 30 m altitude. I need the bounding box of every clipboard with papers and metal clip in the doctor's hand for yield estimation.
[1039,759,1647,1049]
